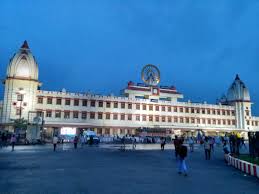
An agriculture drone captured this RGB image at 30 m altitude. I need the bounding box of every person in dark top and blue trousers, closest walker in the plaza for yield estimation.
[178,141,187,176]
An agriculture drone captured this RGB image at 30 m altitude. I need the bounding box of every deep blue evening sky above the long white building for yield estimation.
[0,0,259,115]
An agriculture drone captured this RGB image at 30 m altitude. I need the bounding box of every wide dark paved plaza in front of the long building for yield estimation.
[0,145,259,194]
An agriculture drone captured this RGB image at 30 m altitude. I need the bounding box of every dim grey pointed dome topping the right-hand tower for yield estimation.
[227,75,250,101]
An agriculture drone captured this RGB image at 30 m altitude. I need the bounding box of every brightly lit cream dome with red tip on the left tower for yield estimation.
[7,41,39,80]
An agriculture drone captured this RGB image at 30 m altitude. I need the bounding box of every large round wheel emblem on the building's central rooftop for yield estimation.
[141,64,160,86]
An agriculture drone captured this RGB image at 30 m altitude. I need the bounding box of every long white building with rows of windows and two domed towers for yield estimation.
[0,41,259,138]
